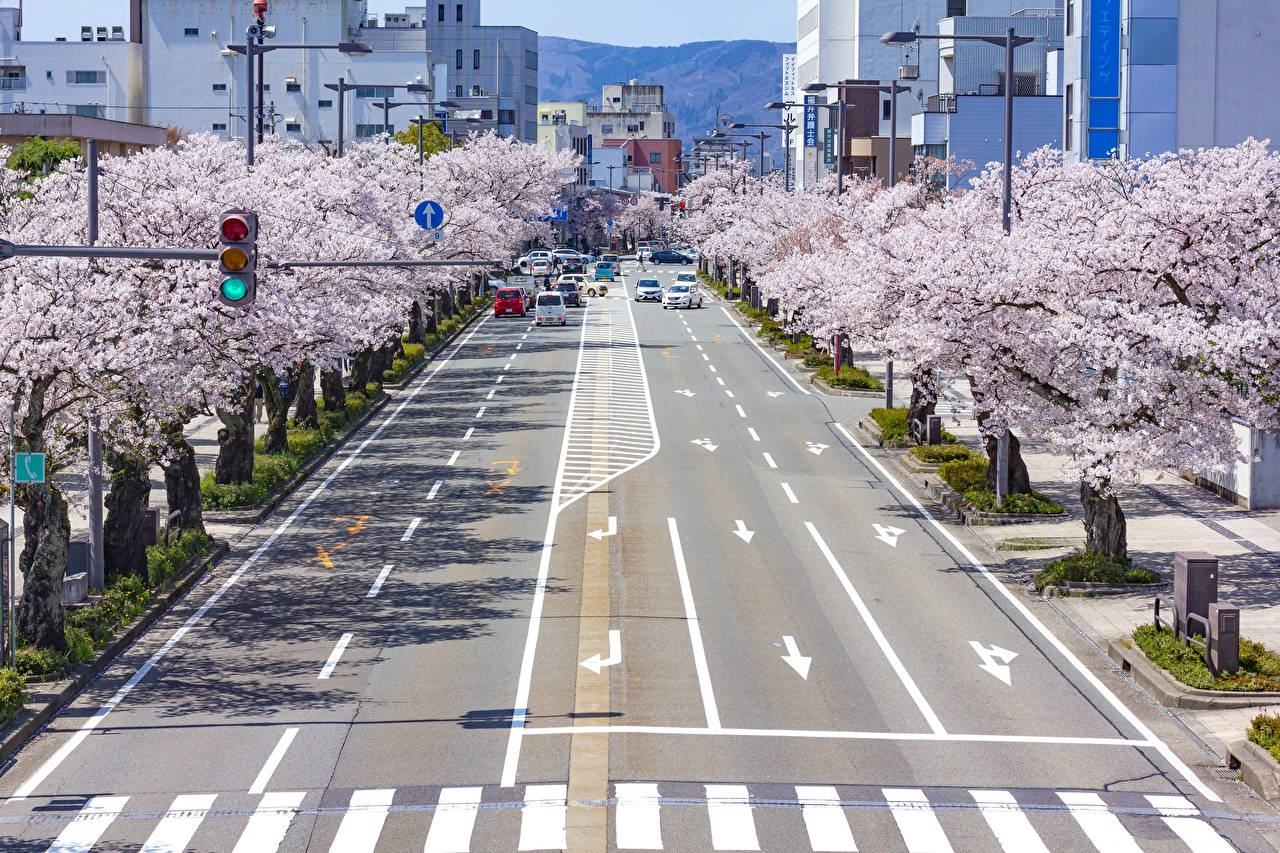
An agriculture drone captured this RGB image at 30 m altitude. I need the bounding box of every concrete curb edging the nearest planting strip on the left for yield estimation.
[0,542,230,765]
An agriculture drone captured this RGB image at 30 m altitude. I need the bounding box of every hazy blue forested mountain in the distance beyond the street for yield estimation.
[538,36,795,164]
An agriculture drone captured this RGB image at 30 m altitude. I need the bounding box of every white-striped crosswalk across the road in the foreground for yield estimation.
[10,781,1235,853]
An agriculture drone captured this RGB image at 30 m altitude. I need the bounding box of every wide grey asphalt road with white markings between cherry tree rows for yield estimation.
[0,265,1280,852]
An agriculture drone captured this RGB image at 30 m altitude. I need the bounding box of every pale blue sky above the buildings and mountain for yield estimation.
[20,0,796,45]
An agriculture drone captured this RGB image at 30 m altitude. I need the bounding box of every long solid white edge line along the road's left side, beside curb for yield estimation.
[5,306,504,802]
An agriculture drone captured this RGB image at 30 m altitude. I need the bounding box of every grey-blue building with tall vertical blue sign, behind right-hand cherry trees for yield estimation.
[1062,0,1280,161]
